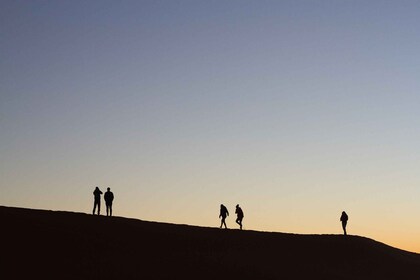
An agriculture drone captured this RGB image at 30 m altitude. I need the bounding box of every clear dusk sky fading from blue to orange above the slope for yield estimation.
[0,0,420,252]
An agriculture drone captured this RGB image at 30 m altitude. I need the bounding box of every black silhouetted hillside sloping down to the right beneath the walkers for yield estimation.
[0,207,420,280]
